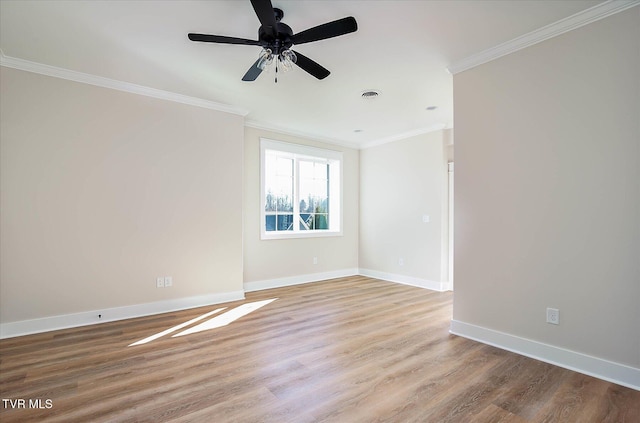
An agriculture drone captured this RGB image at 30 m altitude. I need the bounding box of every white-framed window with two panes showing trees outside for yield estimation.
[260,139,342,239]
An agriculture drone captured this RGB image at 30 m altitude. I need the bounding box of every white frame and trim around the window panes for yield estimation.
[260,138,343,240]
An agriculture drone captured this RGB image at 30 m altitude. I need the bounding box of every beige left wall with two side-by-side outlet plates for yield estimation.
[0,67,243,324]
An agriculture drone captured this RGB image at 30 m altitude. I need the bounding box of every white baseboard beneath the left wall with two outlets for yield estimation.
[0,291,244,339]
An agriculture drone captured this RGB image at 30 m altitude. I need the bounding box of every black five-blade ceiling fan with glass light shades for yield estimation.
[189,0,358,82]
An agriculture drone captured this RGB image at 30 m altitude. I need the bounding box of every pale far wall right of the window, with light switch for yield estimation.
[359,131,448,289]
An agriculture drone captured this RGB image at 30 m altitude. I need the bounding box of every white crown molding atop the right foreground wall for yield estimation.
[447,0,640,75]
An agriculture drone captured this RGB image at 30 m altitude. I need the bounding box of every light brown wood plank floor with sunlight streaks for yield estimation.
[0,277,640,423]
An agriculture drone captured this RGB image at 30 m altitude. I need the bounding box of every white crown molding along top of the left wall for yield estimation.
[0,50,249,117]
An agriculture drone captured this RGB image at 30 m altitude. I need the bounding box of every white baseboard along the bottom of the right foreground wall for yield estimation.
[449,320,640,391]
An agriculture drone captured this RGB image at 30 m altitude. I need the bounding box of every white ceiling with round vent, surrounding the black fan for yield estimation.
[0,0,601,147]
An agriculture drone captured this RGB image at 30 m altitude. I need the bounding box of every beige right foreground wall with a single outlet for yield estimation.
[453,7,640,368]
